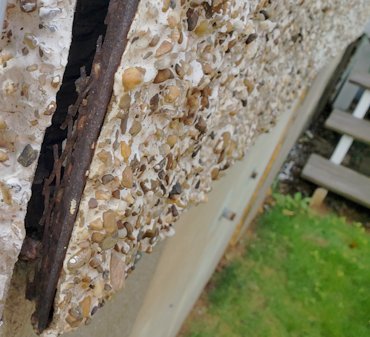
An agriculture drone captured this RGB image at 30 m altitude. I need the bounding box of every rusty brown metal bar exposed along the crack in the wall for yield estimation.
[30,0,139,332]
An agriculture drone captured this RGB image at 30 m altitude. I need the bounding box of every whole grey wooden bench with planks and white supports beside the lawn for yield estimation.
[302,36,370,208]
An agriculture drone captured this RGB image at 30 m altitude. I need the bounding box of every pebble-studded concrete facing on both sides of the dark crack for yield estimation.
[0,0,370,336]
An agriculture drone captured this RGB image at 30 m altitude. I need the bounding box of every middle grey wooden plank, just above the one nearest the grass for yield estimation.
[325,108,370,144]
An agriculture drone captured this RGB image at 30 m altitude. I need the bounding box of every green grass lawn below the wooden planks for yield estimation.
[185,194,370,337]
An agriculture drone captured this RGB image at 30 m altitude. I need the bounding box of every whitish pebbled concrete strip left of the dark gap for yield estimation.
[0,0,75,324]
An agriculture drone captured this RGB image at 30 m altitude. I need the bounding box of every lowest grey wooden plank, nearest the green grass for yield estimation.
[302,154,370,208]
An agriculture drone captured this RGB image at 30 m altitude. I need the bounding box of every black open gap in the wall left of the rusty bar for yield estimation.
[25,0,109,241]
